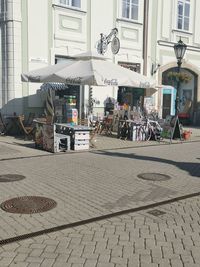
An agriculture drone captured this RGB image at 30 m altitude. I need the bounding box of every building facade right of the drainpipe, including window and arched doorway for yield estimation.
[149,0,200,124]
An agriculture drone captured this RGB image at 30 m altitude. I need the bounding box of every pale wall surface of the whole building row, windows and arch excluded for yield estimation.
[0,0,200,123]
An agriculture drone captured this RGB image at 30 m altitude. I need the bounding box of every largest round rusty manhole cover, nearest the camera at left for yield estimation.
[1,196,57,214]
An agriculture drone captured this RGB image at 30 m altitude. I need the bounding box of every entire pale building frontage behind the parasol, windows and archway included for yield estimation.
[0,0,200,124]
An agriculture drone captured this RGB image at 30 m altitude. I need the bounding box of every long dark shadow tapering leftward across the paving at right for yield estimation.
[92,150,200,177]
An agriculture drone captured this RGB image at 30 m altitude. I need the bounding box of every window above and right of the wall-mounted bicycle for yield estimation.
[122,0,139,20]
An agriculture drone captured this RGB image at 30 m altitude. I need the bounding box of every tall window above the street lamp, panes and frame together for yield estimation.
[177,0,190,31]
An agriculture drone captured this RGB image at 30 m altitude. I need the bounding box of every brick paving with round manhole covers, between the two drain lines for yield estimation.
[0,140,200,243]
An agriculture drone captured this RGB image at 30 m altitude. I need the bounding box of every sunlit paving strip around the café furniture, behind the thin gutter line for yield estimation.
[0,127,200,160]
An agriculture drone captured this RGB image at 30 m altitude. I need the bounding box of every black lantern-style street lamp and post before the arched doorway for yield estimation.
[174,38,187,115]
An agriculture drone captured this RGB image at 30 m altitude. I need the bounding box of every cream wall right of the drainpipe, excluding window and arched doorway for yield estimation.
[149,0,200,122]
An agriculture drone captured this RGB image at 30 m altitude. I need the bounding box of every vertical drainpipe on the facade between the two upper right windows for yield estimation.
[143,0,149,75]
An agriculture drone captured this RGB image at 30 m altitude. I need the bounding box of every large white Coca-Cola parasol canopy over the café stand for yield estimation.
[21,52,155,88]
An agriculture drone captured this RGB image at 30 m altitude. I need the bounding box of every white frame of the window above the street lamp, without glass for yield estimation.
[176,0,191,31]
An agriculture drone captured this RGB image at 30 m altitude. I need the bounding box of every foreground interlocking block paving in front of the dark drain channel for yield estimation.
[0,197,200,267]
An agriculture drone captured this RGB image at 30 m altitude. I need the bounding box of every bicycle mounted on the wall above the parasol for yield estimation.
[97,28,120,55]
